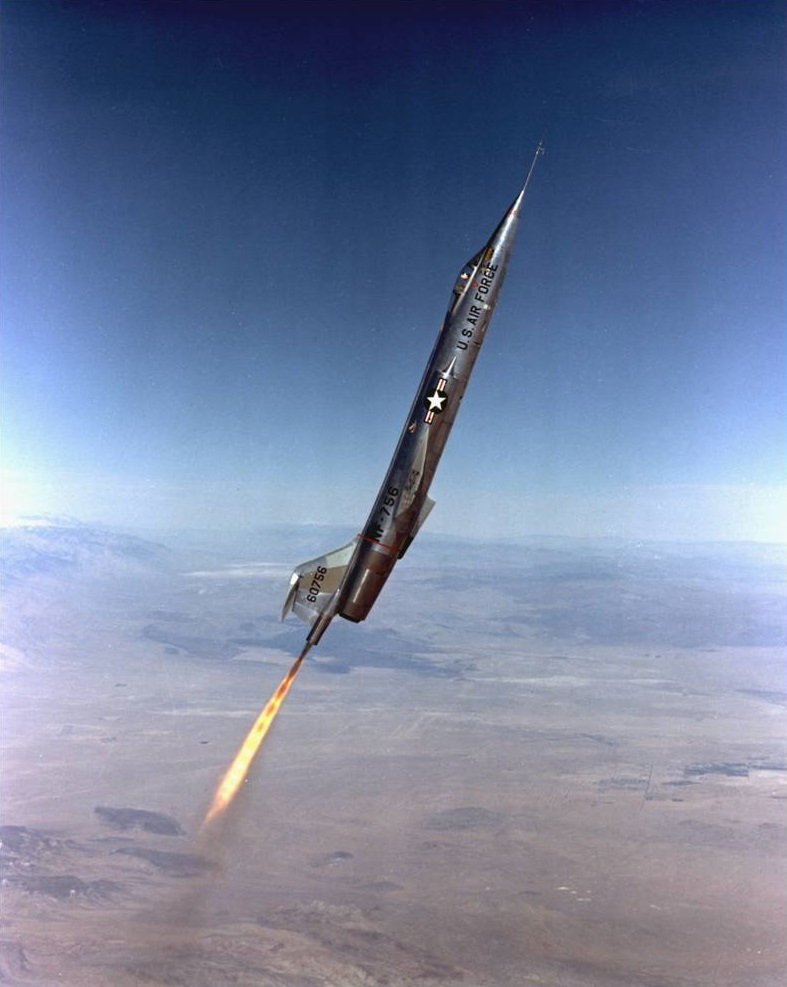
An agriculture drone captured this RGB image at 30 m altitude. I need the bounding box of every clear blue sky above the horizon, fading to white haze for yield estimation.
[2,0,787,539]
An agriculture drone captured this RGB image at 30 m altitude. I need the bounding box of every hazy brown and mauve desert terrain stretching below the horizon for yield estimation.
[0,524,787,987]
